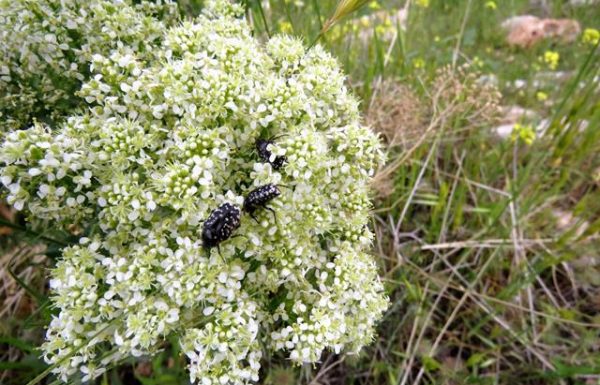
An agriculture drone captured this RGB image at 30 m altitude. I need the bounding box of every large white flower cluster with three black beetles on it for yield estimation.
[0,0,387,385]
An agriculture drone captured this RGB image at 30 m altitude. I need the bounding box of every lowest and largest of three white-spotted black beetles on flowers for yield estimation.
[202,203,240,249]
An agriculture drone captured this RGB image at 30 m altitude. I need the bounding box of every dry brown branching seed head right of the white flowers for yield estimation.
[366,65,502,198]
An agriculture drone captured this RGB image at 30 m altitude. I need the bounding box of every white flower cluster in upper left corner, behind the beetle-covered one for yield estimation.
[0,0,177,132]
